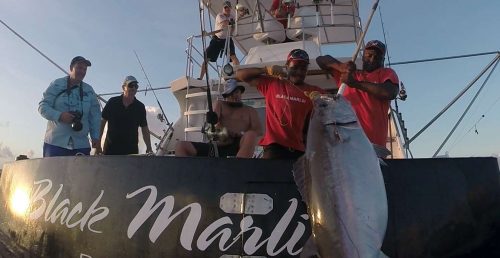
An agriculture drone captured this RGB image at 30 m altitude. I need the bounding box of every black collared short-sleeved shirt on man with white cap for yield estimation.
[102,95,148,155]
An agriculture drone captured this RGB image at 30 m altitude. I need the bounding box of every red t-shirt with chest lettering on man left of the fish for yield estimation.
[257,76,325,151]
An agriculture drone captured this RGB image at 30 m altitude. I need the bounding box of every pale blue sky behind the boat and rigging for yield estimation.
[0,0,500,165]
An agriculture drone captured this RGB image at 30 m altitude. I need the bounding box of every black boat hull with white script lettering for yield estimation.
[0,156,500,257]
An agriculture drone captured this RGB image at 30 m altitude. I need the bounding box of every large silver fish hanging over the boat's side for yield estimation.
[293,96,387,258]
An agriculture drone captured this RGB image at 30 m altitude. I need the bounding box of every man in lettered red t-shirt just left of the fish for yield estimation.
[236,49,325,159]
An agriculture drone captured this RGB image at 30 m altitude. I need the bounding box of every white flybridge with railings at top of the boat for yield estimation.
[202,0,362,54]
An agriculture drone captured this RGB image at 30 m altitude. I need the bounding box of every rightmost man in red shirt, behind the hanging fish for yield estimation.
[316,40,399,148]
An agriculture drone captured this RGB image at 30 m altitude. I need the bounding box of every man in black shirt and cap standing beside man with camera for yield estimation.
[96,76,153,155]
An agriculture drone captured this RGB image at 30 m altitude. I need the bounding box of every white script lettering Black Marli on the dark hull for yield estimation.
[28,179,309,257]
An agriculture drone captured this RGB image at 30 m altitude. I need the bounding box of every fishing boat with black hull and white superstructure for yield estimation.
[0,0,500,258]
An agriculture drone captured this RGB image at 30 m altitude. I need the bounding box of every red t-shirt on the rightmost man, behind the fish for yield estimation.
[334,68,399,146]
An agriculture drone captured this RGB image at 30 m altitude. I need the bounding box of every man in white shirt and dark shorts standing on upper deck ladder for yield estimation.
[198,1,240,80]
